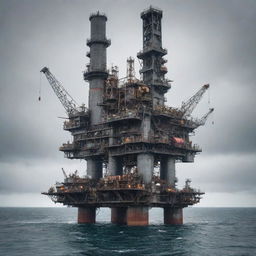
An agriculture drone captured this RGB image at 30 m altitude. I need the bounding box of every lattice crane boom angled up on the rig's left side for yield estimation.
[40,67,78,116]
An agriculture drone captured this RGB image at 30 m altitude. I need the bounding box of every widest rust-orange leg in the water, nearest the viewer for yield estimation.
[127,206,148,226]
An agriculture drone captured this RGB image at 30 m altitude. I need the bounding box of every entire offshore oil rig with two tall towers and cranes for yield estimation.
[41,7,213,226]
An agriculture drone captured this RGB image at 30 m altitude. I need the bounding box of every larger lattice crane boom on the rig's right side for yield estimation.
[180,84,210,117]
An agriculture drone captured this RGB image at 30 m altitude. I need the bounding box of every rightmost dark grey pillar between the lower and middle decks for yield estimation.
[160,156,176,188]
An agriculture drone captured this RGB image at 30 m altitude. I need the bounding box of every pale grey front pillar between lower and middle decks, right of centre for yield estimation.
[137,153,154,184]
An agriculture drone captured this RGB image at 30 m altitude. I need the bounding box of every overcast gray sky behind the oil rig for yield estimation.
[0,0,256,206]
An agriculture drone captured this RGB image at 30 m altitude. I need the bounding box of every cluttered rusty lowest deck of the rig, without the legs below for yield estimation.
[45,172,204,207]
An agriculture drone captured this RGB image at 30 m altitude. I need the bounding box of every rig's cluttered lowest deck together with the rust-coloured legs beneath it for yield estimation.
[42,173,204,226]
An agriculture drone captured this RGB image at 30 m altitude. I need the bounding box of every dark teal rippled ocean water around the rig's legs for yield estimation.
[0,208,256,256]
